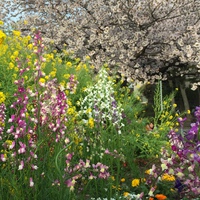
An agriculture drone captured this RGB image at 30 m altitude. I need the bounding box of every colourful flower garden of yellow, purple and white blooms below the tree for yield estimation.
[0,23,200,200]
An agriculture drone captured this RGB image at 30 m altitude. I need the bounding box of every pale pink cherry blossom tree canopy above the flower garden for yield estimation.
[0,0,200,89]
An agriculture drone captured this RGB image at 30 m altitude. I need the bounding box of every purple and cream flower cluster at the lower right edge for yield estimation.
[148,107,200,199]
